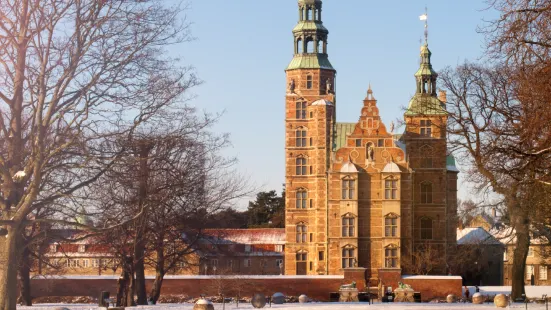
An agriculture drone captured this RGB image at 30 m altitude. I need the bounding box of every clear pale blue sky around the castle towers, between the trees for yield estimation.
[174,0,495,208]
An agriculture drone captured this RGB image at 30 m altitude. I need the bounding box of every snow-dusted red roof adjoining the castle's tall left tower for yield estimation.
[204,228,285,244]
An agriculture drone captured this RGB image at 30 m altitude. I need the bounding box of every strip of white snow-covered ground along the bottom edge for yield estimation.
[17,303,546,310]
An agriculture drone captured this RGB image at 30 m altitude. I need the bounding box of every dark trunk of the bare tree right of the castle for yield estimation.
[511,212,530,300]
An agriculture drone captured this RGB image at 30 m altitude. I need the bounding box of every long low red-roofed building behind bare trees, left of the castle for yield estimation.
[35,228,285,275]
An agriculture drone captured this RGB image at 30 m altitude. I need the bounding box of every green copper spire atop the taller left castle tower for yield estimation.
[286,0,334,70]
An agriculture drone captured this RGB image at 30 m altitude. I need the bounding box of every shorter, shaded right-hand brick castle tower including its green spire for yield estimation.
[404,43,457,273]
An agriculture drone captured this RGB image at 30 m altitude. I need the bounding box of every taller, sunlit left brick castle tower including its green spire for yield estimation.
[285,0,336,275]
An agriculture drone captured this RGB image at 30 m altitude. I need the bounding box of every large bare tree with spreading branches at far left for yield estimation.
[0,0,197,309]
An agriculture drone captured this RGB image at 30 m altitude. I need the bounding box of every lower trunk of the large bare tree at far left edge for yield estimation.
[0,228,19,310]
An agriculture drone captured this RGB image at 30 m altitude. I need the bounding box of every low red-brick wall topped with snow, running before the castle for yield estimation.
[28,271,461,301]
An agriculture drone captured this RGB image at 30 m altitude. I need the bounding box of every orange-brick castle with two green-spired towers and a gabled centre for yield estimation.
[285,0,458,279]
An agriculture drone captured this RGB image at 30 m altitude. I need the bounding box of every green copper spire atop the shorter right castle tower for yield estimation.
[405,42,446,116]
